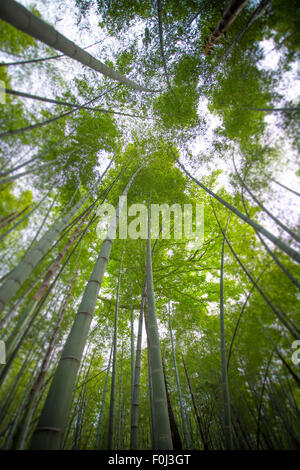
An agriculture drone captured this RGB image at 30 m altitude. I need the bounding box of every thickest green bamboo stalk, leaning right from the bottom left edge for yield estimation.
[31,168,141,449]
